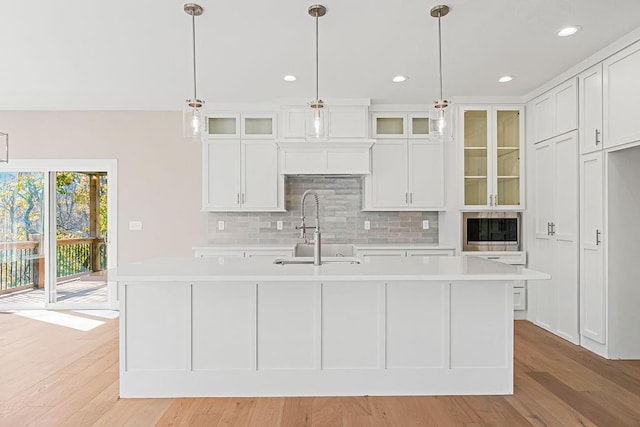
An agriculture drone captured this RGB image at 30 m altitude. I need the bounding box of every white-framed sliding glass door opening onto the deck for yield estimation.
[0,160,117,310]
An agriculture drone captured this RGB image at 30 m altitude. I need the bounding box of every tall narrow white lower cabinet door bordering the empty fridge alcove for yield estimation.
[580,152,607,344]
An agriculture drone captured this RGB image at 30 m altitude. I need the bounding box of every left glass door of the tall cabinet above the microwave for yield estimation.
[462,109,491,206]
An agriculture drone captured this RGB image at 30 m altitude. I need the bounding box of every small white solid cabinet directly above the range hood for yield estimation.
[280,102,369,139]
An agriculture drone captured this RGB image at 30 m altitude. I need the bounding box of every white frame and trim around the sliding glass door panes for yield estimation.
[0,159,118,310]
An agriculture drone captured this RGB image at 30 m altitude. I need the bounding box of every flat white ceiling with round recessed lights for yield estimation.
[0,0,640,110]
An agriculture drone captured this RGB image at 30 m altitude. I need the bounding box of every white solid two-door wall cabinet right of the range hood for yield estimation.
[363,139,445,210]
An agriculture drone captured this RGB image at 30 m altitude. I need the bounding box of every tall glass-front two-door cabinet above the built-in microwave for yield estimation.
[460,106,524,210]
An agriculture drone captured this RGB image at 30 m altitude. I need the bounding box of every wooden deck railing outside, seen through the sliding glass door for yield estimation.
[0,238,107,294]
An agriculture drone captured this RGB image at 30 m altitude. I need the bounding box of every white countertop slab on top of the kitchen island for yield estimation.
[109,256,550,282]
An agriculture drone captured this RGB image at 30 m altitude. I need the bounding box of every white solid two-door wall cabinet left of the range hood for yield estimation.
[202,139,284,211]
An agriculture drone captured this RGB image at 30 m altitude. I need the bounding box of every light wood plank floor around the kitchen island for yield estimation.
[0,313,640,427]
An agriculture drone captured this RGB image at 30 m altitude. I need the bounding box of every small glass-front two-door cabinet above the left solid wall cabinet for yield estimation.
[207,113,276,139]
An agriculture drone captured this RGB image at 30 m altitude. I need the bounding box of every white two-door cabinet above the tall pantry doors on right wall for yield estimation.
[527,78,578,142]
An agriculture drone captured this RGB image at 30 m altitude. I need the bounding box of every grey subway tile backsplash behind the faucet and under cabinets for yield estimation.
[207,176,438,245]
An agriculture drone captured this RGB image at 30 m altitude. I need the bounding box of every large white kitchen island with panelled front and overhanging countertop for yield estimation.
[114,256,549,397]
